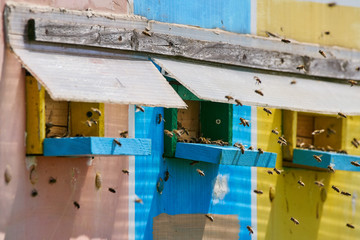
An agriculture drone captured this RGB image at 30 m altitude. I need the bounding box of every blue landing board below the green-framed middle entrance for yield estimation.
[175,143,277,168]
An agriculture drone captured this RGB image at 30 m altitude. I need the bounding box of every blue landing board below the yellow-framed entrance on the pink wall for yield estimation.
[44,137,151,156]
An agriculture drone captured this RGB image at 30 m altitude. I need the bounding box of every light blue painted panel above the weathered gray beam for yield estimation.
[134,0,251,33]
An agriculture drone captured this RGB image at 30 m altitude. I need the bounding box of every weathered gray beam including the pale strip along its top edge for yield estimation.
[4,2,360,80]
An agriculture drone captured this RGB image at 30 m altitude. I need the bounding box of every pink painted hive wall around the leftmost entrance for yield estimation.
[0,0,128,240]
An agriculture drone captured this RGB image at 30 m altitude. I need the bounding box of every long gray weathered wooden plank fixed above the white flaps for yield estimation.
[28,18,360,79]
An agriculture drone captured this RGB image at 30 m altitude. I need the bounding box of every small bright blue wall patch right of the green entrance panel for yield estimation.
[232,105,252,147]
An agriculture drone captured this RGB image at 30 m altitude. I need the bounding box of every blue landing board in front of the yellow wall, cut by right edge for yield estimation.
[293,149,360,172]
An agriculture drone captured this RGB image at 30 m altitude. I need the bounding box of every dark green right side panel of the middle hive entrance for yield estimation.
[200,101,233,144]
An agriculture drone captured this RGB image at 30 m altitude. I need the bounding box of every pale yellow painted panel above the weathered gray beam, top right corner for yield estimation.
[257,0,360,50]
